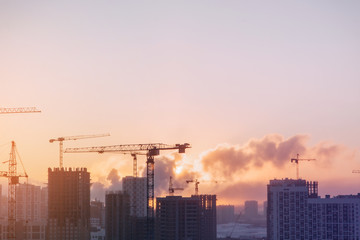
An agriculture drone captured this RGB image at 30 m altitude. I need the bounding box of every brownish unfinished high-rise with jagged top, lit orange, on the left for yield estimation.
[47,168,90,240]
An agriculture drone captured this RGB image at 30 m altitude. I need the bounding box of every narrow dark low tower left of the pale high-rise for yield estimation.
[105,191,132,240]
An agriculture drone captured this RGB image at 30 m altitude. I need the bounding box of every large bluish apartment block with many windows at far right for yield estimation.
[267,179,360,240]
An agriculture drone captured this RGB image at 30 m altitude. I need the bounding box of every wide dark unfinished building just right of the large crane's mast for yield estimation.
[155,195,216,240]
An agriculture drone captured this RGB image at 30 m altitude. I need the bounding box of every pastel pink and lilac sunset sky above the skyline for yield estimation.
[0,0,360,204]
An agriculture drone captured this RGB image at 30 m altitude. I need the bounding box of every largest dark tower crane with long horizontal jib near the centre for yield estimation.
[65,143,191,240]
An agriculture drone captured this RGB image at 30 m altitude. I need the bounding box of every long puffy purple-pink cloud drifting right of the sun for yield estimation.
[201,134,346,179]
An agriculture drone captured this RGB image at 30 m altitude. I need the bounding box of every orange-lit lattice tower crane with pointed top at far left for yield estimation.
[0,141,28,240]
